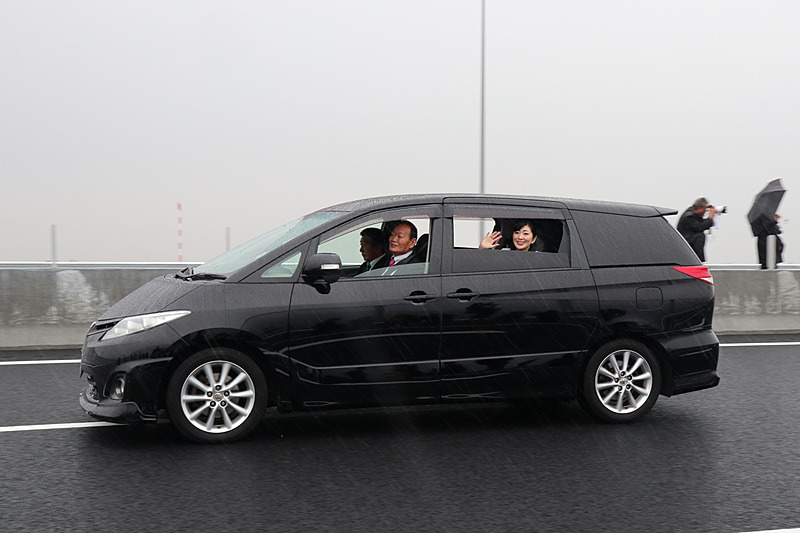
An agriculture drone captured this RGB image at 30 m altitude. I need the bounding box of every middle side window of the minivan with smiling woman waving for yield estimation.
[452,208,571,272]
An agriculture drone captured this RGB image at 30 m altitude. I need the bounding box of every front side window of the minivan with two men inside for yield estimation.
[317,213,432,279]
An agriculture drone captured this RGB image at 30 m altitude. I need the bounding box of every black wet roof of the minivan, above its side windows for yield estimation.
[319,193,678,217]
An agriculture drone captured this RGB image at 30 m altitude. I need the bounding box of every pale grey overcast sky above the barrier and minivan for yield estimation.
[0,0,800,263]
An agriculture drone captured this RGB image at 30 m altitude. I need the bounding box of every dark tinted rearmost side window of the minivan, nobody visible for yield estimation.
[572,210,700,267]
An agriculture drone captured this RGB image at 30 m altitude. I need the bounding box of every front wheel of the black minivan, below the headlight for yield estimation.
[167,348,267,443]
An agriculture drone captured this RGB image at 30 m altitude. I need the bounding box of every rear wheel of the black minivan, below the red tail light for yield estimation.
[581,339,661,423]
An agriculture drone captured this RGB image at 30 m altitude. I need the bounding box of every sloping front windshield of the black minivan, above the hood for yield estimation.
[194,211,342,275]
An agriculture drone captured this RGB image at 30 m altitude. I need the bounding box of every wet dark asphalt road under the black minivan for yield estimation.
[0,340,800,532]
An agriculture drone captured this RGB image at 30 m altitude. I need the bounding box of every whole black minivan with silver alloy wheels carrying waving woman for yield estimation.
[80,194,719,442]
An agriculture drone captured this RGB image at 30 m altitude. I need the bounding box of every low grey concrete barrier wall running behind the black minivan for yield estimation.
[0,266,800,349]
